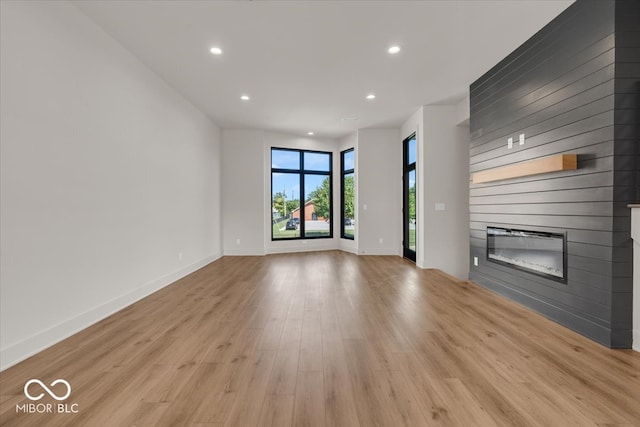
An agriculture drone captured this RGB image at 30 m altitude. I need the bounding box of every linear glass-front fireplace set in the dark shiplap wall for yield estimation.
[487,227,567,283]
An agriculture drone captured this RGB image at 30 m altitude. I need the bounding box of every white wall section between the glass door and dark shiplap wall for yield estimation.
[401,99,469,279]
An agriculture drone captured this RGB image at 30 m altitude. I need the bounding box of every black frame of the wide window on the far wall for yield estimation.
[269,147,333,242]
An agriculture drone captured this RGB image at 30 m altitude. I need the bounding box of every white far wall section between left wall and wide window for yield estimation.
[222,130,270,255]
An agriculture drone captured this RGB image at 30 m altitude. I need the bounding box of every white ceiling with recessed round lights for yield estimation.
[74,0,572,137]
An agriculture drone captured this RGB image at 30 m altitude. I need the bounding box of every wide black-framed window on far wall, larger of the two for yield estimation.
[271,148,333,240]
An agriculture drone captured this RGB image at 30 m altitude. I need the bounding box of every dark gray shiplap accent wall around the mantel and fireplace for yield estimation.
[470,0,640,347]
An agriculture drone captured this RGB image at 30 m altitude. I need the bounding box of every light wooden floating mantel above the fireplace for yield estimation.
[473,154,578,184]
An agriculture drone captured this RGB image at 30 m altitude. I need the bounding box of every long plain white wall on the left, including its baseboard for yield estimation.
[0,1,221,369]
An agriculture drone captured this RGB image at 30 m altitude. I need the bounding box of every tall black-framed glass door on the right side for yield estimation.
[402,133,416,262]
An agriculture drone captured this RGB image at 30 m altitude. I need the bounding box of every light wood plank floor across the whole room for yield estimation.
[0,252,640,427]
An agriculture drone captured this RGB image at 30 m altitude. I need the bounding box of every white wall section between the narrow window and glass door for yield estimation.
[356,129,402,255]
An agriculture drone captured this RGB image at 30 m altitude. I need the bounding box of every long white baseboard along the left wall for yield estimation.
[0,254,221,371]
